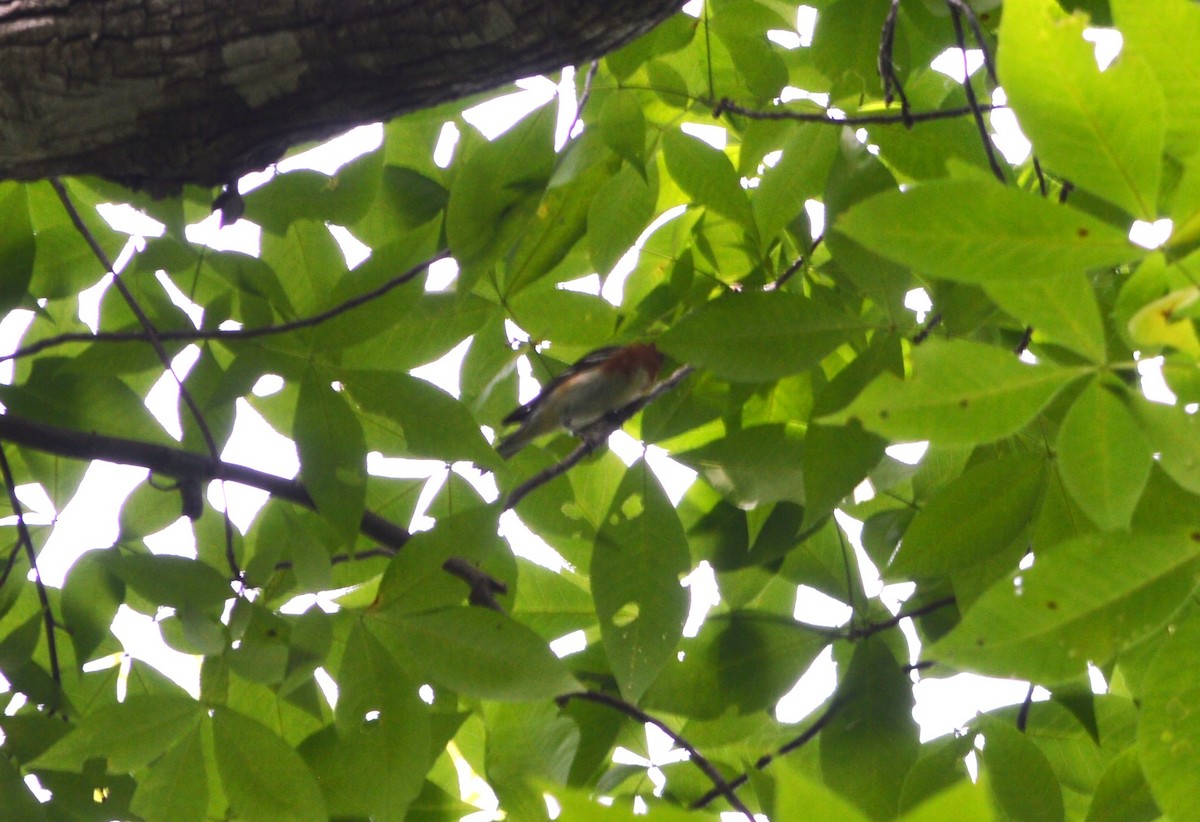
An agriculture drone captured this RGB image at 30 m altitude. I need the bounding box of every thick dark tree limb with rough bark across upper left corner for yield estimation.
[0,0,680,193]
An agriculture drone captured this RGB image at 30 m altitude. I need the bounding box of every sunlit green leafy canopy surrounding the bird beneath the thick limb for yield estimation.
[0,0,1200,821]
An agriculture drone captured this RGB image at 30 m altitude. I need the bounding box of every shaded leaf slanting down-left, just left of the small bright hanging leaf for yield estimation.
[890,455,1046,577]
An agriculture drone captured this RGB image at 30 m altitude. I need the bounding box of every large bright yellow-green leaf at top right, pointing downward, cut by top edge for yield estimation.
[998,0,1161,220]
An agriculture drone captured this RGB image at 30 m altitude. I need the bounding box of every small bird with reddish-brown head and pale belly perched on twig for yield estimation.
[496,342,662,460]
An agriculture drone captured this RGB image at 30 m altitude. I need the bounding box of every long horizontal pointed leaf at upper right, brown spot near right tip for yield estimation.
[834,180,1146,283]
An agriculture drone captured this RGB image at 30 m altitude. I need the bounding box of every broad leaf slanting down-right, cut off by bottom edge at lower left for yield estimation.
[212,706,329,822]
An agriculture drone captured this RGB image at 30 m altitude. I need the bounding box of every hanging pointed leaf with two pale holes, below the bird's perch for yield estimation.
[590,461,690,703]
